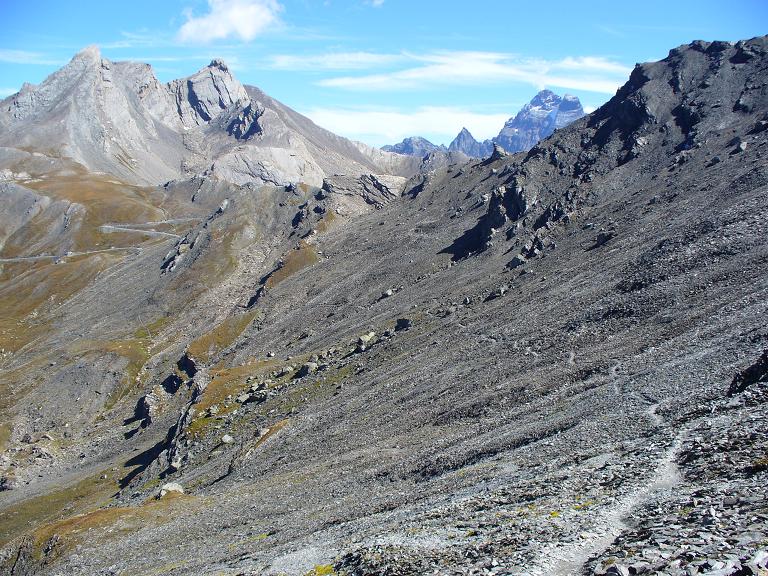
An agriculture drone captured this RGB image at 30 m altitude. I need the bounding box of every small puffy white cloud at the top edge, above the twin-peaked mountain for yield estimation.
[178,0,283,44]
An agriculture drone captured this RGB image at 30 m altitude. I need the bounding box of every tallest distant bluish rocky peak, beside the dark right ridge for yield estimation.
[493,90,584,152]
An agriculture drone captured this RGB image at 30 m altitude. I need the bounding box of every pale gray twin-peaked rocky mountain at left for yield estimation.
[0,47,416,186]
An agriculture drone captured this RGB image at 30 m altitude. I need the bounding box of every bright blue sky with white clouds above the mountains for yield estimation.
[0,0,768,145]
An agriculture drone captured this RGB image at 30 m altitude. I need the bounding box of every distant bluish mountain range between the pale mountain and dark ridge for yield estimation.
[382,90,584,158]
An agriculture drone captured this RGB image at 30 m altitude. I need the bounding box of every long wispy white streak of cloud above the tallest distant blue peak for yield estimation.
[319,52,631,94]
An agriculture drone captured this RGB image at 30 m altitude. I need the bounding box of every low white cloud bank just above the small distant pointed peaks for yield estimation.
[303,106,509,146]
